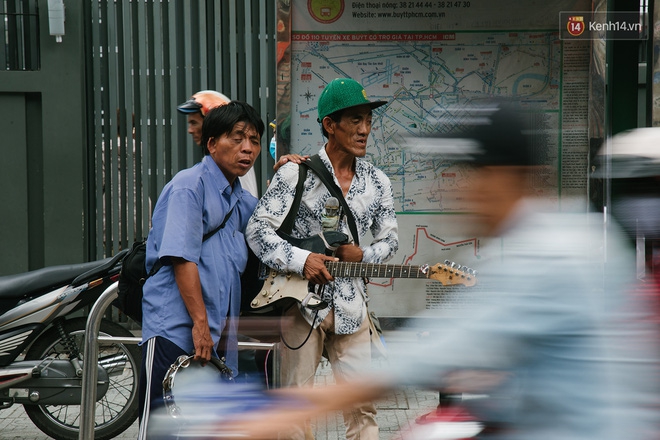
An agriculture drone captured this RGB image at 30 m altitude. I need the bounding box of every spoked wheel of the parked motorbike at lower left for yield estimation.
[24,318,142,440]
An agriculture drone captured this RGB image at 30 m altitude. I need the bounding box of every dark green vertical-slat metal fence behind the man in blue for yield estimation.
[83,0,276,258]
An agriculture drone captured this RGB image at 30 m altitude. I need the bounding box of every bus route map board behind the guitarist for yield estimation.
[288,0,591,317]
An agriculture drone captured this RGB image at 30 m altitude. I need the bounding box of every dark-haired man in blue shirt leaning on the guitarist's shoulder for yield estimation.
[139,101,265,438]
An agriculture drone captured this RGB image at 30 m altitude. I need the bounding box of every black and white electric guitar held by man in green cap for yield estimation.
[250,231,477,313]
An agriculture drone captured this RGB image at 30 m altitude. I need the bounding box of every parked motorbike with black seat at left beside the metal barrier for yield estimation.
[0,251,141,440]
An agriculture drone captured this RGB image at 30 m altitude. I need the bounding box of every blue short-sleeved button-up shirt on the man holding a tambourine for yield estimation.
[142,156,257,372]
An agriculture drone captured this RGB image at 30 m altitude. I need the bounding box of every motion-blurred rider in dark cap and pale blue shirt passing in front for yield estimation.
[227,103,660,440]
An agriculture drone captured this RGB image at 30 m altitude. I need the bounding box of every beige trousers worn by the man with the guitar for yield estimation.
[281,307,378,440]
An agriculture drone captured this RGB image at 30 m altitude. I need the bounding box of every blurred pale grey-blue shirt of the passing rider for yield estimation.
[391,203,658,440]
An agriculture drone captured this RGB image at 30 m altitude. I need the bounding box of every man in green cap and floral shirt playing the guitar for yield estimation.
[246,78,398,440]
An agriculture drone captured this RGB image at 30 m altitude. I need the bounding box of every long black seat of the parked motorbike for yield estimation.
[0,260,106,300]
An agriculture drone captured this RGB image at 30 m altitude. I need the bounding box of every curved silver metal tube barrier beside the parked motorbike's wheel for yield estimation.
[78,282,280,440]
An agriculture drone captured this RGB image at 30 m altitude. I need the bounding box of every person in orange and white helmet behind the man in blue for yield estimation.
[176,90,259,198]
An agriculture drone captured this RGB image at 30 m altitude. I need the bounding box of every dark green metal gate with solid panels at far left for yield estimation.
[0,0,90,276]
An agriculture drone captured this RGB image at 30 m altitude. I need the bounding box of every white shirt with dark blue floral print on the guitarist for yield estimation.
[246,147,399,334]
